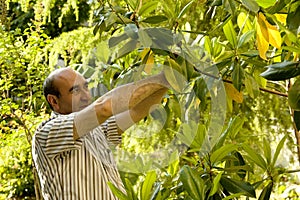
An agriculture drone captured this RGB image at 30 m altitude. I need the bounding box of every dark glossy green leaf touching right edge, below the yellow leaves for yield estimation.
[260,61,300,81]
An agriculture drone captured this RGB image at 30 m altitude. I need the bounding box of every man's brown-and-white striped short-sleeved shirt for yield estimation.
[32,114,124,200]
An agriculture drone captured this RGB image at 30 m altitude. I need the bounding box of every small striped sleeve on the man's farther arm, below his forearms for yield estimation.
[101,117,122,145]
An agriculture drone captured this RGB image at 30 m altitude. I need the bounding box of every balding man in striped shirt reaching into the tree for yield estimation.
[32,68,168,200]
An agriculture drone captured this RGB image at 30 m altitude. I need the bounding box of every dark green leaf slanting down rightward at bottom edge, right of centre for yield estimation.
[220,176,256,198]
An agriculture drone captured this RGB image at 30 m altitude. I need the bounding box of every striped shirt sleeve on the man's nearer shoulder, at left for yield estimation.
[39,114,82,157]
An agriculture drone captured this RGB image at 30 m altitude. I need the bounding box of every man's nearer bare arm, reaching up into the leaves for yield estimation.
[74,73,169,139]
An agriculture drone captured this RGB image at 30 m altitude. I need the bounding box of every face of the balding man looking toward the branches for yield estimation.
[54,69,91,114]
